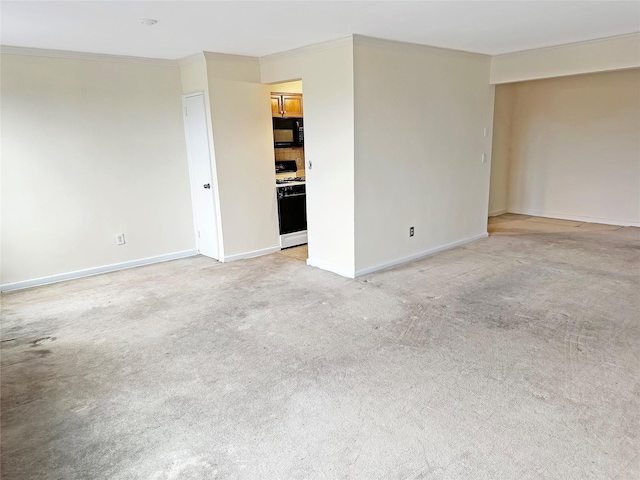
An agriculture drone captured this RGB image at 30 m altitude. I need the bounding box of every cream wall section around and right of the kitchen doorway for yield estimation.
[261,38,355,277]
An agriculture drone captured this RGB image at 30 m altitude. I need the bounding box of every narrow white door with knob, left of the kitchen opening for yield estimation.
[184,93,219,260]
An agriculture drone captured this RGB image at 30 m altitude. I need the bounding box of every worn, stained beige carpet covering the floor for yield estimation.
[1,219,640,480]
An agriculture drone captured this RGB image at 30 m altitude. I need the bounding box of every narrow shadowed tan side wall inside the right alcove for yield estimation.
[489,84,514,217]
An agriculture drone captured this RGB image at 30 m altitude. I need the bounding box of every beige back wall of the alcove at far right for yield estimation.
[496,69,640,226]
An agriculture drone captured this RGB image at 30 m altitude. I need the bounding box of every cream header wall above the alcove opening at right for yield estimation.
[491,33,640,83]
